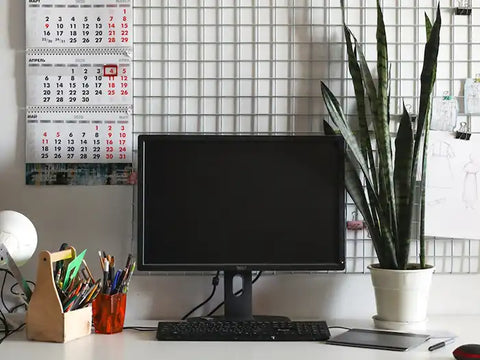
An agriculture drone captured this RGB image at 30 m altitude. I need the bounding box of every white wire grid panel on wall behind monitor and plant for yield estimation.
[134,0,480,273]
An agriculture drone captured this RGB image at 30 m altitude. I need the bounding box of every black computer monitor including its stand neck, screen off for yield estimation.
[138,135,345,319]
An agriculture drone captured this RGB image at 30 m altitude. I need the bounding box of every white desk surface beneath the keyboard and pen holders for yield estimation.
[0,315,480,360]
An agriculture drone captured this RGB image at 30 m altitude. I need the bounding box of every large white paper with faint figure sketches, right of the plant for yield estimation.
[425,131,480,239]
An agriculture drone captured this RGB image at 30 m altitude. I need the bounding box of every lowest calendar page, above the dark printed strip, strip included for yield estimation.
[26,107,132,184]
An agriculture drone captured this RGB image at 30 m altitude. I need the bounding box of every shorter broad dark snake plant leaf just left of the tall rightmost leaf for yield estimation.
[394,105,413,269]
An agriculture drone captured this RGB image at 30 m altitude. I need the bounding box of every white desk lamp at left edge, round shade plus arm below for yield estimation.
[0,210,37,304]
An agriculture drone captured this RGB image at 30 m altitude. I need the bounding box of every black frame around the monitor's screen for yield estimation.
[136,134,346,272]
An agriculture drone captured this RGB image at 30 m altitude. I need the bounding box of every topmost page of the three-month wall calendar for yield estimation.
[25,0,132,48]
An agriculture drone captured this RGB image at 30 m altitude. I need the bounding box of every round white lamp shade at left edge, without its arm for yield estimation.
[0,210,37,266]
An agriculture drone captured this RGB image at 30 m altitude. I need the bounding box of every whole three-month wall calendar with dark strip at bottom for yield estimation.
[26,0,135,185]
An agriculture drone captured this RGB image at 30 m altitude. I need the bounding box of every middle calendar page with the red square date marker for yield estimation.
[26,49,132,106]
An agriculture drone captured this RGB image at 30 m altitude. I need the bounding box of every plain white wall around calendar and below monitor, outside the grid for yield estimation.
[0,0,480,319]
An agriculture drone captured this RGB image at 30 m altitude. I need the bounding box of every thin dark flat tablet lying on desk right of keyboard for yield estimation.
[327,329,430,351]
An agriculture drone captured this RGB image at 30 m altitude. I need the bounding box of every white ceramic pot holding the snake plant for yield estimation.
[368,265,434,330]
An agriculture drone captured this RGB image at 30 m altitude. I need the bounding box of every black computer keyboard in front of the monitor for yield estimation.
[157,320,330,341]
